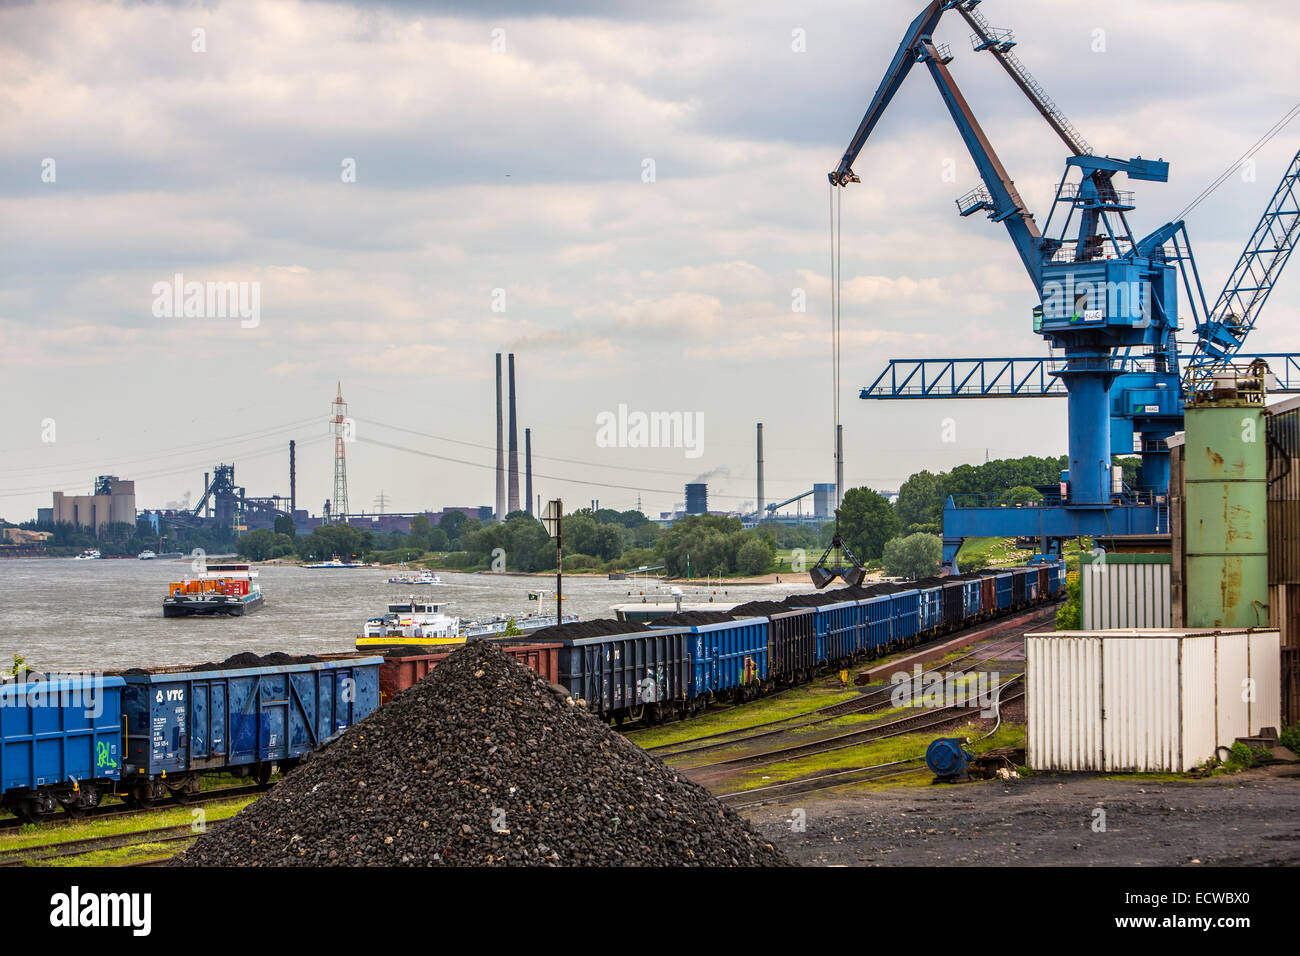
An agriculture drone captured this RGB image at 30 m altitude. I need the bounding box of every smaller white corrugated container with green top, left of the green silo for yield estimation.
[1079,554,1174,631]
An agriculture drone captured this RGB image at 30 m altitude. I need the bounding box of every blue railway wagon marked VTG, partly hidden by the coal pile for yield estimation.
[120,654,384,806]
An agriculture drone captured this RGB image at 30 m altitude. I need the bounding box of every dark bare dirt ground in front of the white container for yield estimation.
[745,765,1300,866]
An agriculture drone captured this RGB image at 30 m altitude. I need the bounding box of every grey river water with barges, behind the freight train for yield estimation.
[0,558,811,670]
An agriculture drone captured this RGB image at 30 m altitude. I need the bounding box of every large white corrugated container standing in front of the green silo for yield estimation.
[1024,629,1282,773]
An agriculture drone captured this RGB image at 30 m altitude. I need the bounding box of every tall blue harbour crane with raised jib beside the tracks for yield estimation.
[829,0,1300,567]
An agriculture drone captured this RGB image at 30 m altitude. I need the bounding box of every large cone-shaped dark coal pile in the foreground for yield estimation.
[172,641,788,866]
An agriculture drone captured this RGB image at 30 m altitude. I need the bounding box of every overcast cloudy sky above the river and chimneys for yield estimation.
[0,0,1300,520]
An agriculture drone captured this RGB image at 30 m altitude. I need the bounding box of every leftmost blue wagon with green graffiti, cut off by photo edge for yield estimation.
[0,675,126,819]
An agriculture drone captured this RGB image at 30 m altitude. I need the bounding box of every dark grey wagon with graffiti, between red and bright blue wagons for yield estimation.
[559,627,694,723]
